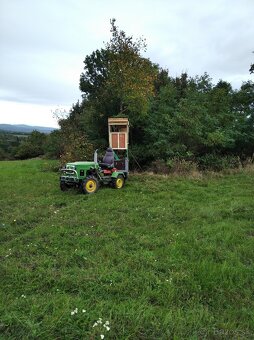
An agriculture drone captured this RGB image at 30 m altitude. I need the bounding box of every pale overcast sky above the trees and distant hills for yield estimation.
[0,0,254,127]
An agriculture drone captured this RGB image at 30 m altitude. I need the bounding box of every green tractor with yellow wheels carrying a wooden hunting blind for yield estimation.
[60,118,129,194]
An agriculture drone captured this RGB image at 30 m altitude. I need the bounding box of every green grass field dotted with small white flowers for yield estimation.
[0,160,254,339]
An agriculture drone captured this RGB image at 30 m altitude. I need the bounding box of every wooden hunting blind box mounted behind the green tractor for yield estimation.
[108,118,129,150]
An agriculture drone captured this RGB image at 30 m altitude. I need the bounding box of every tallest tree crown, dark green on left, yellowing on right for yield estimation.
[80,19,158,124]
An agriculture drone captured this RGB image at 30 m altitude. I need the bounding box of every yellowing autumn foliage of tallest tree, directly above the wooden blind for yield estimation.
[106,20,157,120]
